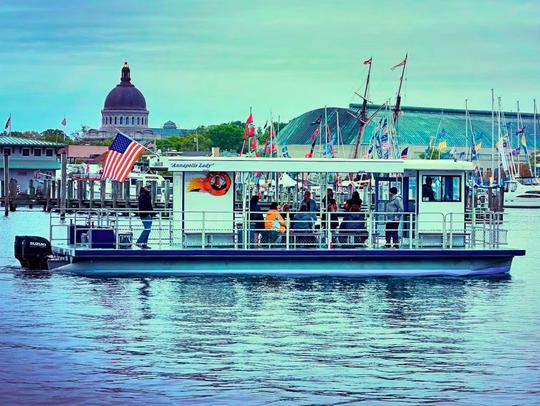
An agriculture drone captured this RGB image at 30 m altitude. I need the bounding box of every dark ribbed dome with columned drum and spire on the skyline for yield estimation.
[101,62,148,130]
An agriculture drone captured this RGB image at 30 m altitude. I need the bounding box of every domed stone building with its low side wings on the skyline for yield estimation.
[81,62,191,142]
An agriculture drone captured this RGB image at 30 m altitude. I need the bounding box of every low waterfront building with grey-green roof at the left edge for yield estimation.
[0,136,64,193]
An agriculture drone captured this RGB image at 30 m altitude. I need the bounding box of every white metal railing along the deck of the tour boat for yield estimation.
[49,209,506,250]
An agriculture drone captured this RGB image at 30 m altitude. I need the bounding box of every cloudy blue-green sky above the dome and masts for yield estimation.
[0,0,540,133]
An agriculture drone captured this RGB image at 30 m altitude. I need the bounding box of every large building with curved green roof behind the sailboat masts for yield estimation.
[277,104,540,168]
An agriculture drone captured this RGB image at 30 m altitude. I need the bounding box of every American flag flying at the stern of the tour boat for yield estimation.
[102,133,144,182]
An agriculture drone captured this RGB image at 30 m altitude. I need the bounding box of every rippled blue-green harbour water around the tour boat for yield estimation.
[0,210,540,405]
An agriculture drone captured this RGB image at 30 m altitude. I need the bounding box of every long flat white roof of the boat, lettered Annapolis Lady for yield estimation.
[150,156,474,173]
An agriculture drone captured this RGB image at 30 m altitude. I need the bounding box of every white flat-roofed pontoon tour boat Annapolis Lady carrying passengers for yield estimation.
[15,157,525,277]
